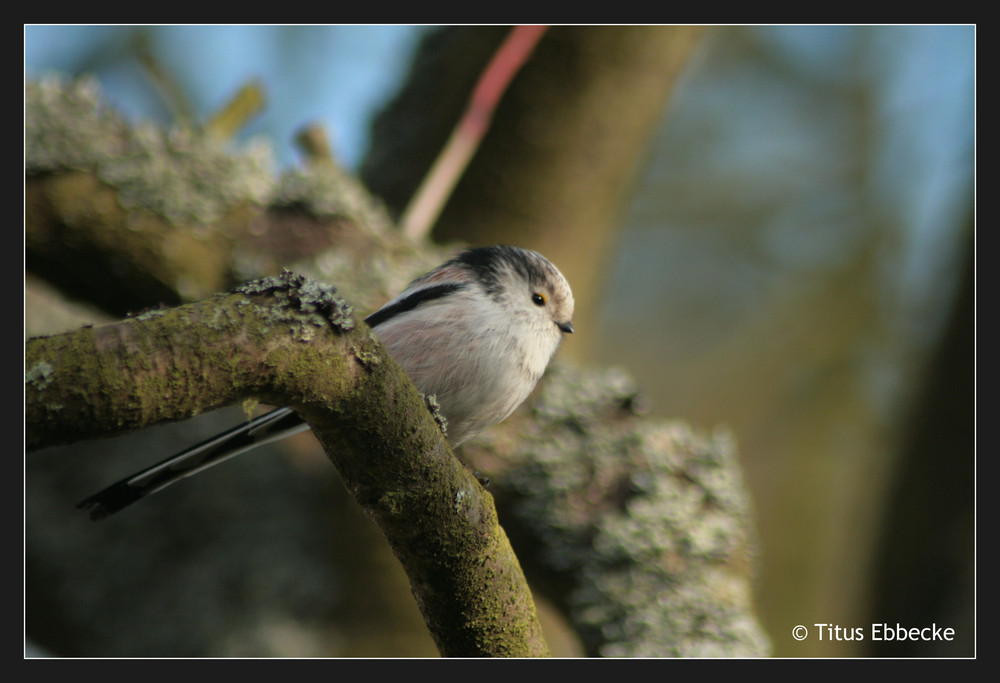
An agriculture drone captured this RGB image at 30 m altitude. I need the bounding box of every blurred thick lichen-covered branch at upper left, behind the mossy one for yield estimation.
[24,78,398,317]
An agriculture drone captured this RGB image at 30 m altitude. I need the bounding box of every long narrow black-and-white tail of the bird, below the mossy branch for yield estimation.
[76,408,309,520]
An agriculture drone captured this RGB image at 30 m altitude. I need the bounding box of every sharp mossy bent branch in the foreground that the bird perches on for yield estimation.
[25,272,547,656]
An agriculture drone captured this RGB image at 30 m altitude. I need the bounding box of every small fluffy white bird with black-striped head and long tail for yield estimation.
[77,246,573,520]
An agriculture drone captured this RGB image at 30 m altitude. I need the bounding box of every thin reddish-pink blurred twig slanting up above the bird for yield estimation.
[400,26,548,240]
